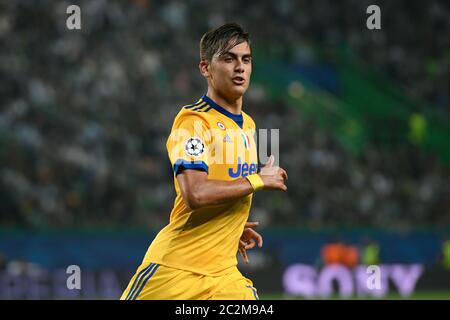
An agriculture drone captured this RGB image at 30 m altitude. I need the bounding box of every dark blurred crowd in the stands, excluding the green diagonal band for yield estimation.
[0,0,450,229]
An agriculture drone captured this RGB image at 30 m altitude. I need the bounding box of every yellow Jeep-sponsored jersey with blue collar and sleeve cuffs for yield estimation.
[143,95,258,276]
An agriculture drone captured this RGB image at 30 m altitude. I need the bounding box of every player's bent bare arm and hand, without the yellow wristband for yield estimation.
[177,157,287,209]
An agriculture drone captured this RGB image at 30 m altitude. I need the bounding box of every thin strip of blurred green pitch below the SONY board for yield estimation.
[259,291,450,300]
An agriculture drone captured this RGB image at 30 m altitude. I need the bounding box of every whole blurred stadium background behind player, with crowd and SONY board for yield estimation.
[0,0,450,299]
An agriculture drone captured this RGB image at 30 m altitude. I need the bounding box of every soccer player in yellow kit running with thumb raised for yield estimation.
[121,23,287,300]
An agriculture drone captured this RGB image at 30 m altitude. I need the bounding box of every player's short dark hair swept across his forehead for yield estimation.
[200,23,250,61]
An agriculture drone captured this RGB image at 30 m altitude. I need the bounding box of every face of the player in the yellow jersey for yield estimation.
[200,42,252,99]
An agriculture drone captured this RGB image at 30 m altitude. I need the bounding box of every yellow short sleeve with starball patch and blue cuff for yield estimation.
[167,115,211,175]
